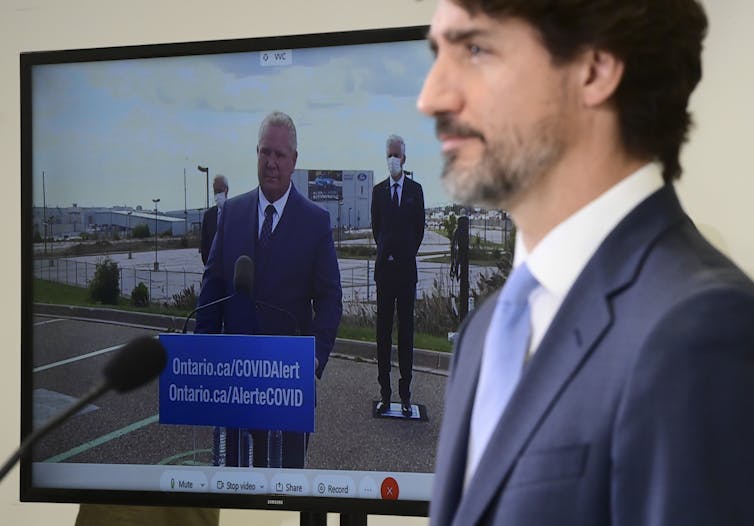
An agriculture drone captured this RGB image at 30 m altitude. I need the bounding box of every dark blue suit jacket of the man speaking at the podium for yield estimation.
[196,186,342,377]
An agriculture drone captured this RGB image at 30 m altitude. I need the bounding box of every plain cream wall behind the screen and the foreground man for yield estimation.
[0,0,754,526]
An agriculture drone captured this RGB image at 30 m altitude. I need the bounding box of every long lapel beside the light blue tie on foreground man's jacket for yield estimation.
[446,186,687,525]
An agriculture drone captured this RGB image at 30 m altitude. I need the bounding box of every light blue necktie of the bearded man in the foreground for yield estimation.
[466,264,539,483]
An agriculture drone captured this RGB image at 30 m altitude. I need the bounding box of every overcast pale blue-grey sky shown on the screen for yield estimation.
[33,35,450,210]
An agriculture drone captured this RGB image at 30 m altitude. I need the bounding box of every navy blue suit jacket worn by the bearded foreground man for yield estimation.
[430,186,754,526]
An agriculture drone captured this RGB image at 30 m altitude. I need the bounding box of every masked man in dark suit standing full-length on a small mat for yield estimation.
[372,135,424,416]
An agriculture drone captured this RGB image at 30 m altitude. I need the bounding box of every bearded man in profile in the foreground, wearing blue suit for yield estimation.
[418,0,754,526]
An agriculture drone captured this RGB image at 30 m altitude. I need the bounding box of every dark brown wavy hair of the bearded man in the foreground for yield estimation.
[453,0,707,181]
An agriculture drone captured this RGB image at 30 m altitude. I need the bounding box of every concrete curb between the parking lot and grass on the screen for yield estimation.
[34,303,451,374]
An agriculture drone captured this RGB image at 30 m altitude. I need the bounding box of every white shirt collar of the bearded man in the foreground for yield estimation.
[513,163,663,297]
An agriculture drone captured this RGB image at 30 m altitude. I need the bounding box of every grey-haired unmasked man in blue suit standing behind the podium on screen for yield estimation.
[196,112,342,468]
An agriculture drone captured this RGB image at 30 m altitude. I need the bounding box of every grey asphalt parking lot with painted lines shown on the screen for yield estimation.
[32,314,445,472]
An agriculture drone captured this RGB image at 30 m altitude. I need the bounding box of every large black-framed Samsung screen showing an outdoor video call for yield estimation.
[21,27,507,515]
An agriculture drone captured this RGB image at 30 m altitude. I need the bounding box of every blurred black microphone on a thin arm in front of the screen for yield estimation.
[0,336,167,480]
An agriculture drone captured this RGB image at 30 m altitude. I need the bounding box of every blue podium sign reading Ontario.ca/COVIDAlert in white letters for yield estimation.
[160,334,314,432]
